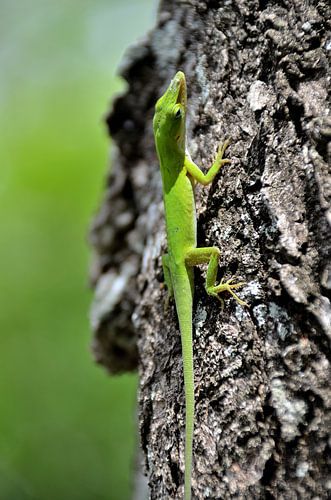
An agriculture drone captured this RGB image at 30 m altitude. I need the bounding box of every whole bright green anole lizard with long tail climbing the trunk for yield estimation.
[153,71,247,500]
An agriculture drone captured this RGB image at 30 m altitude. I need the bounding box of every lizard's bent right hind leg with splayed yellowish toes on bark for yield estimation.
[185,247,248,307]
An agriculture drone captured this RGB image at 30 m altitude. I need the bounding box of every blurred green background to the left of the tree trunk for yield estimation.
[0,0,155,500]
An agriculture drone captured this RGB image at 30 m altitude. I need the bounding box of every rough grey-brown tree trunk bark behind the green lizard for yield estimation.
[92,0,331,499]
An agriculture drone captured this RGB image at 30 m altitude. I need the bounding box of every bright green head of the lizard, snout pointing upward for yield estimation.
[153,71,187,149]
